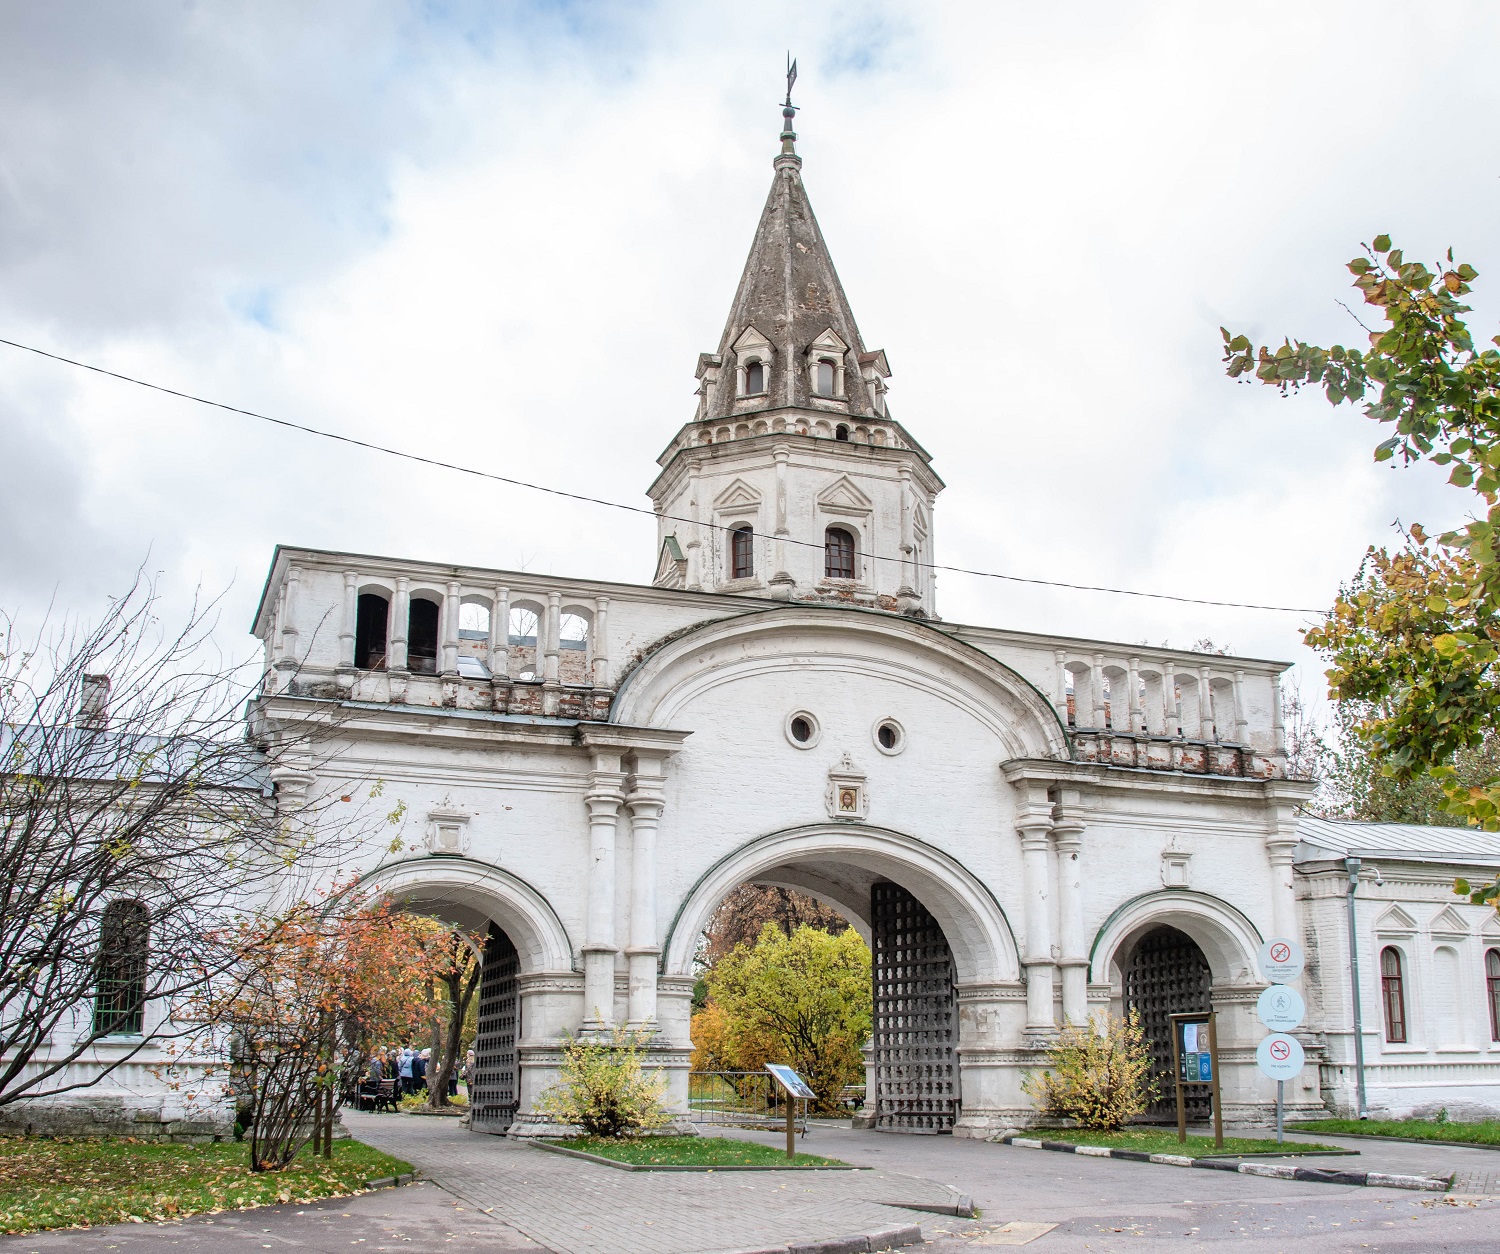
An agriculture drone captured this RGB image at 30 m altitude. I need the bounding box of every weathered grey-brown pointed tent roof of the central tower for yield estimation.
[704,108,884,419]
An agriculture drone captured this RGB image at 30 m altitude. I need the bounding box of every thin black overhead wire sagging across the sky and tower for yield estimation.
[0,339,1323,614]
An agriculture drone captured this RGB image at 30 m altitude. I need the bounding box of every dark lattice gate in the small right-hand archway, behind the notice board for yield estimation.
[1125,927,1214,1121]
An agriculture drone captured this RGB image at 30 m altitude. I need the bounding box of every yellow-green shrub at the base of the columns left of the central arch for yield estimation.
[537,1028,672,1137]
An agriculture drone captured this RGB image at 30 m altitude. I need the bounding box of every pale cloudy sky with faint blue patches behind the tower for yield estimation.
[0,0,1500,705]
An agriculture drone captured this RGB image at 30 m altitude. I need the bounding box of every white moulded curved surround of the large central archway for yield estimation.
[662,824,1020,984]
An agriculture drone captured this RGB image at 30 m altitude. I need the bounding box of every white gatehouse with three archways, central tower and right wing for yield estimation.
[11,100,1500,1136]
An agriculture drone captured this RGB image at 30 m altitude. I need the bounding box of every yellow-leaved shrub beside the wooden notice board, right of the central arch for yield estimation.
[1022,1011,1157,1133]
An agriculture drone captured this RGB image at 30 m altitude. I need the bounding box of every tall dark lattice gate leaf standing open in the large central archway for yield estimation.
[870,884,959,1133]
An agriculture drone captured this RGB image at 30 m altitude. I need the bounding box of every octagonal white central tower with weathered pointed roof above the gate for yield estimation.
[650,82,944,617]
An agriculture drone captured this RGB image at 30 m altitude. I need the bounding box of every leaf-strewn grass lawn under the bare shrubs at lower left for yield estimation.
[0,1137,411,1233]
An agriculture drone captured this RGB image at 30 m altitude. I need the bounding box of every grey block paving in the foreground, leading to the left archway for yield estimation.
[344,1113,959,1254]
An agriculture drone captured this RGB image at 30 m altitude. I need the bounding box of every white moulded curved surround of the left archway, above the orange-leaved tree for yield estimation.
[356,858,576,974]
